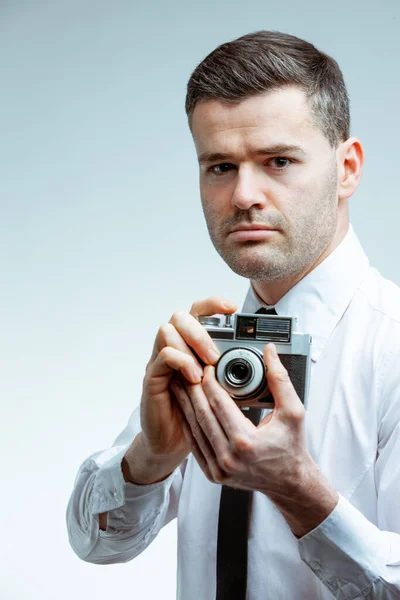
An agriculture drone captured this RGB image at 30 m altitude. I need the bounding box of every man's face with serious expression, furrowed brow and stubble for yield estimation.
[192,87,338,283]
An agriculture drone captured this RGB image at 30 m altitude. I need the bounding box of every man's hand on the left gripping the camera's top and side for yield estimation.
[122,297,236,483]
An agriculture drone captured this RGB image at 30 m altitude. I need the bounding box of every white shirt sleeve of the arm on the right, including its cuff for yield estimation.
[298,340,400,600]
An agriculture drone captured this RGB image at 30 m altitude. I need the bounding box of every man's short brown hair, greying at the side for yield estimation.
[185,31,350,147]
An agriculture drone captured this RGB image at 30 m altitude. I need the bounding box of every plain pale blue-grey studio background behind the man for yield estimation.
[0,0,400,600]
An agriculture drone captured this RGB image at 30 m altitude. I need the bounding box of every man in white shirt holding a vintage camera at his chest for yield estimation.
[68,31,400,600]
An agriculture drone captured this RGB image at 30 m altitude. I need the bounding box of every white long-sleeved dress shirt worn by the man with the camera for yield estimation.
[67,226,400,600]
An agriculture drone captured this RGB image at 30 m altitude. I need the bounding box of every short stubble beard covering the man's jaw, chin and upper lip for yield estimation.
[204,162,337,283]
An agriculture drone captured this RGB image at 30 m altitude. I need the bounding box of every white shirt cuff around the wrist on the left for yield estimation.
[91,444,175,515]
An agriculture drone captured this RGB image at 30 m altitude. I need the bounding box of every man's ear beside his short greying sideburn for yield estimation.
[336,137,364,200]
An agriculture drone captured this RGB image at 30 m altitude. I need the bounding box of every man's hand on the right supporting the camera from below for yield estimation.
[171,344,338,536]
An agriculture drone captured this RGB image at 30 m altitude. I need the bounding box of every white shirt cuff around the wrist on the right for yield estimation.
[298,494,388,598]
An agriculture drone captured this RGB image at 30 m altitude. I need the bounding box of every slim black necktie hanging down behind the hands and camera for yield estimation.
[216,308,277,600]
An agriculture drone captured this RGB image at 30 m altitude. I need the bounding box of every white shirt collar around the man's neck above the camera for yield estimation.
[242,225,369,362]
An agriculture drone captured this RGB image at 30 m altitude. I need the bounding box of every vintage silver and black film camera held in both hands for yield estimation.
[199,313,311,408]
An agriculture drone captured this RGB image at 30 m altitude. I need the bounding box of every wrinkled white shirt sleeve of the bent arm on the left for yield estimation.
[66,409,183,564]
